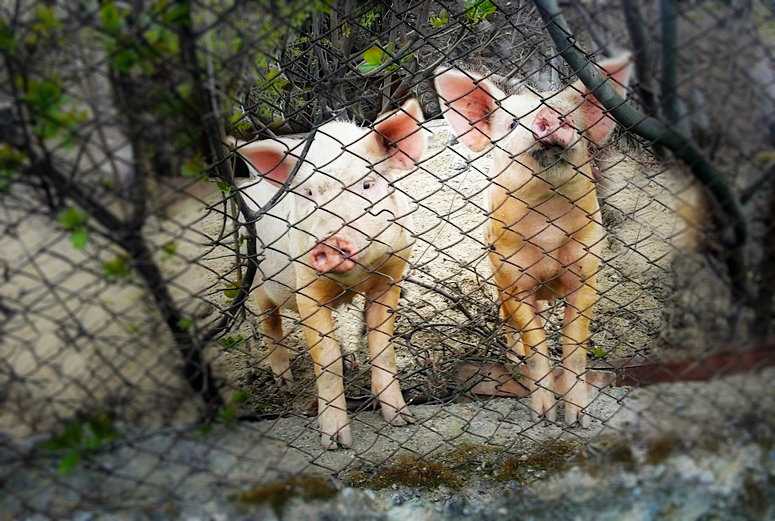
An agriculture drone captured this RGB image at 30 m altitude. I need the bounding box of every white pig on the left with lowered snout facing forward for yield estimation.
[237,99,426,449]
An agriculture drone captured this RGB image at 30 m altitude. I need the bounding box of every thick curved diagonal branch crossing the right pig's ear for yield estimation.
[534,0,751,302]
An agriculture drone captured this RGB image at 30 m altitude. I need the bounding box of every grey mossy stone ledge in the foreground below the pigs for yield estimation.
[0,368,775,521]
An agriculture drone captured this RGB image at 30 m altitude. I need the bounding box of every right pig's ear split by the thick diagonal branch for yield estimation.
[571,53,632,144]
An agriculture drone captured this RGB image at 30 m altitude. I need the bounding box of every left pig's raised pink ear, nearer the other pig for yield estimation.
[371,99,425,170]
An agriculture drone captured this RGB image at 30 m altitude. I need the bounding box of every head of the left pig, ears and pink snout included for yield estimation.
[240,100,425,282]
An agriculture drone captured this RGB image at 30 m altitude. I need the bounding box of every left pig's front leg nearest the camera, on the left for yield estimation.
[296,285,352,449]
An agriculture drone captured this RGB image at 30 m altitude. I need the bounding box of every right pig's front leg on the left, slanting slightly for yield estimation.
[501,288,557,422]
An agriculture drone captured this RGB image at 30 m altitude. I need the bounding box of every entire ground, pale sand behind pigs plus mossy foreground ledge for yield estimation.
[0,100,764,520]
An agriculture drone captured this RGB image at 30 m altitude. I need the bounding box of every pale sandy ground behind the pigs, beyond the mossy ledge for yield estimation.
[0,117,729,438]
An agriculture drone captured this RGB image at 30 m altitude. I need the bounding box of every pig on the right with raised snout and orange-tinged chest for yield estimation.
[435,54,631,427]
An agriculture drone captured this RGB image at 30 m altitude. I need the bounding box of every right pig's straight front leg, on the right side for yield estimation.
[557,276,597,428]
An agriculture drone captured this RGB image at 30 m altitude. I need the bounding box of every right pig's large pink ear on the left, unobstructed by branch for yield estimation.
[434,69,506,152]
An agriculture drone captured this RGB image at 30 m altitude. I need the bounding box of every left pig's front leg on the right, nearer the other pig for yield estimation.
[366,284,414,426]
